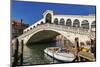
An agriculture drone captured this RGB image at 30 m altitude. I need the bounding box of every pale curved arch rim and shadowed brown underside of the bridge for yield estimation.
[25,28,73,44]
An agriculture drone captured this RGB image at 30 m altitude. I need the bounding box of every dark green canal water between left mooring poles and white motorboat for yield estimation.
[23,43,62,65]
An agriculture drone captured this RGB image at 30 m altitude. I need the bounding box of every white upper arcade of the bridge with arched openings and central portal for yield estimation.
[23,10,96,33]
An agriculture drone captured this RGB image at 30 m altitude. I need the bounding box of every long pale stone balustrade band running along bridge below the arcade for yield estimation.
[19,23,95,38]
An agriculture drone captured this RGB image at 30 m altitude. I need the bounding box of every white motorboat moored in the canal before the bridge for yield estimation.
[44,47,75,62]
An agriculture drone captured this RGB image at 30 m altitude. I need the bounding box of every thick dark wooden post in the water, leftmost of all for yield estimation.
[12,39,19,66]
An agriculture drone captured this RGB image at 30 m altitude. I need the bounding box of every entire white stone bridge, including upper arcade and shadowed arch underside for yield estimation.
[13,10,96,45]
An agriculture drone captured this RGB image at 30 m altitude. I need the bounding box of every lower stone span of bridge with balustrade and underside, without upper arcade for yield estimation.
[12,23,95,45]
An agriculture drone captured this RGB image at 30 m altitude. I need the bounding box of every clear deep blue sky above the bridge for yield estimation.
[11,1,96,25]
